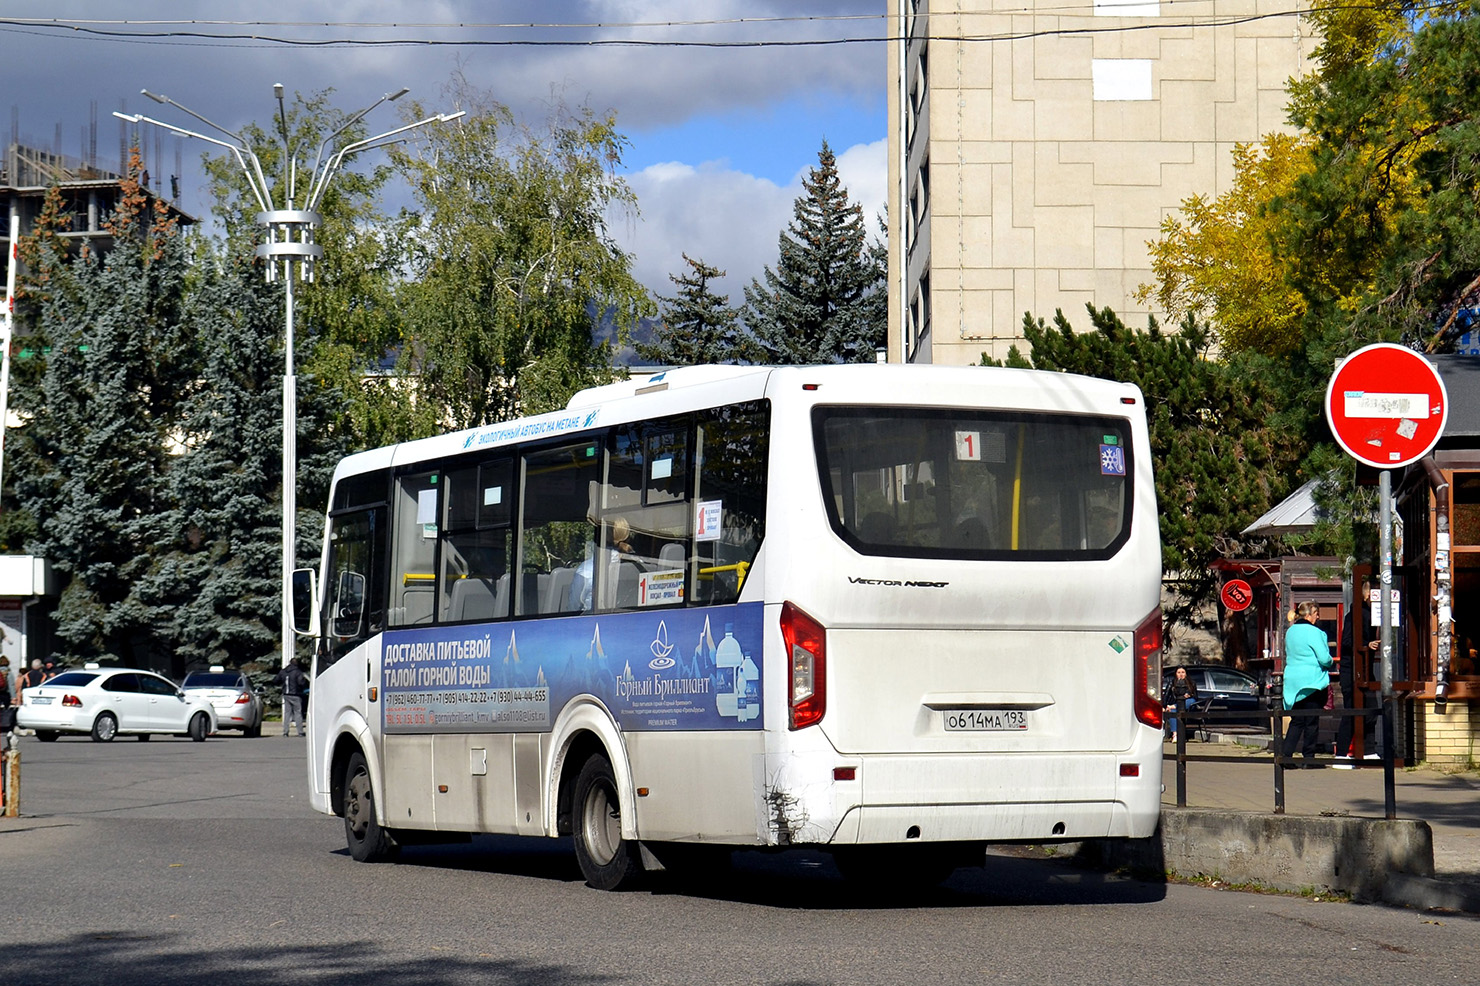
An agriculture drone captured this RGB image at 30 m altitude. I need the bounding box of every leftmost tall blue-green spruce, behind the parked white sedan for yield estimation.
[16,158,201,662]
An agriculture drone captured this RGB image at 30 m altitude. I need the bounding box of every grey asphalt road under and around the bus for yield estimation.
[0,734,1480,986]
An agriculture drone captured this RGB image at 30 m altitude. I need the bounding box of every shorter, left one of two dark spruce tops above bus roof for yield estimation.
[633,253,761,366]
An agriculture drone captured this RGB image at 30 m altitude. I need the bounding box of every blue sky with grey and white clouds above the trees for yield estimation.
[0,0,887,302]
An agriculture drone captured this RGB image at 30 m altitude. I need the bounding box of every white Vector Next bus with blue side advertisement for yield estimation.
[302,364,1162,888]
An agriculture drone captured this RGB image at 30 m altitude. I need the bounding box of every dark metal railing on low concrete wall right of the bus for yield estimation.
[1163,700,1397,819]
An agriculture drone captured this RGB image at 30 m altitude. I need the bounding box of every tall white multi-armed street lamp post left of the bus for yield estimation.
[112,84,463,666]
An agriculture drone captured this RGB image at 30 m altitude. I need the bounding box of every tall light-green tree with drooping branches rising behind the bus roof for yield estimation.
[392,81,653,437]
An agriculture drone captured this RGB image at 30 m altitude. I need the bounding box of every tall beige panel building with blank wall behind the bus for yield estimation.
[888,0,1316,364]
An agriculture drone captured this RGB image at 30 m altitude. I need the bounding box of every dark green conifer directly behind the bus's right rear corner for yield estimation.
[983,306,1301,625]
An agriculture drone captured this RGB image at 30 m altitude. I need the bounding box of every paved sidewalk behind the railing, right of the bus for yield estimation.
[1162,734,1480,913]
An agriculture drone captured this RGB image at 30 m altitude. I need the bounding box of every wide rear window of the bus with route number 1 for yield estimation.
[813,407,1135,560]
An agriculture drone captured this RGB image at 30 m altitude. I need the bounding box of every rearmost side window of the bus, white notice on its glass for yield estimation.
[693,401,770,604]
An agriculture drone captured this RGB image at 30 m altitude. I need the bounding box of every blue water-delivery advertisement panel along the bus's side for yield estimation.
[380,603,764,733]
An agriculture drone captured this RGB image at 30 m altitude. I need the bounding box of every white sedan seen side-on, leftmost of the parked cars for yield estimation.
[15,668,216,743]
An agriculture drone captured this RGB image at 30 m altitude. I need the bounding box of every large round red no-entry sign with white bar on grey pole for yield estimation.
[1326,342,1449,469]
